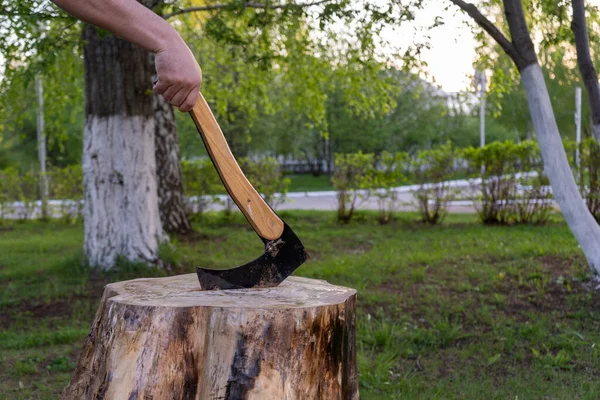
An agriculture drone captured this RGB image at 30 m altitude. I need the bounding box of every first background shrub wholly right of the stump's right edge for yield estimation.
[372,152,409,224]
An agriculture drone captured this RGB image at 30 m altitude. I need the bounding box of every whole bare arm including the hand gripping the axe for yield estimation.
[52,0,202,111]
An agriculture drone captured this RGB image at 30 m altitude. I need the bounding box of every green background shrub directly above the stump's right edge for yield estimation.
[331,152,374,222]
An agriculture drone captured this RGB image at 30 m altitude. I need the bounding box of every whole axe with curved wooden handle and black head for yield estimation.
[190,93,309,290]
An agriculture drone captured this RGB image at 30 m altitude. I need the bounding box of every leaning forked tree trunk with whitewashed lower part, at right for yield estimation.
[451,0,600,275]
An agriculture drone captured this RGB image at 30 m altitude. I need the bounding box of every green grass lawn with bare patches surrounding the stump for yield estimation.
[0,212,600,399]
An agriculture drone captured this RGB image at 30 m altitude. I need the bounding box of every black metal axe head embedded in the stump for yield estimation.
[197,223,309,290]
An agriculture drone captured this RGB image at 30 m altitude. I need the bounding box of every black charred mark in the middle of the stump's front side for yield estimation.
[225,334,262,400]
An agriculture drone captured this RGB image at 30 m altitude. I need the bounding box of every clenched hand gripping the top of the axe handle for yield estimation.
[154,41,202,112]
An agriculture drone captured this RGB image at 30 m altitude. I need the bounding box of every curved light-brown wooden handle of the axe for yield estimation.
[190,93,283,240]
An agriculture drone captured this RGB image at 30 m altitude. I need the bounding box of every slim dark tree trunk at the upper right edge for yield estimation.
[571,0,600,142]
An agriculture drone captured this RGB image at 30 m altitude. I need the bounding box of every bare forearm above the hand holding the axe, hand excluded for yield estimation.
[52,0,182,53]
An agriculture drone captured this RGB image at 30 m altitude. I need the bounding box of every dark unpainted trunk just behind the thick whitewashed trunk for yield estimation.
[153,95,192,233]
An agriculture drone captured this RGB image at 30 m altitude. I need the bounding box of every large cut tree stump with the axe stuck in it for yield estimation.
[62,274,359,400]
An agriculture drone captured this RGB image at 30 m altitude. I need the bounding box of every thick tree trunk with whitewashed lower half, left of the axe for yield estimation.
[83,25,163,269]
